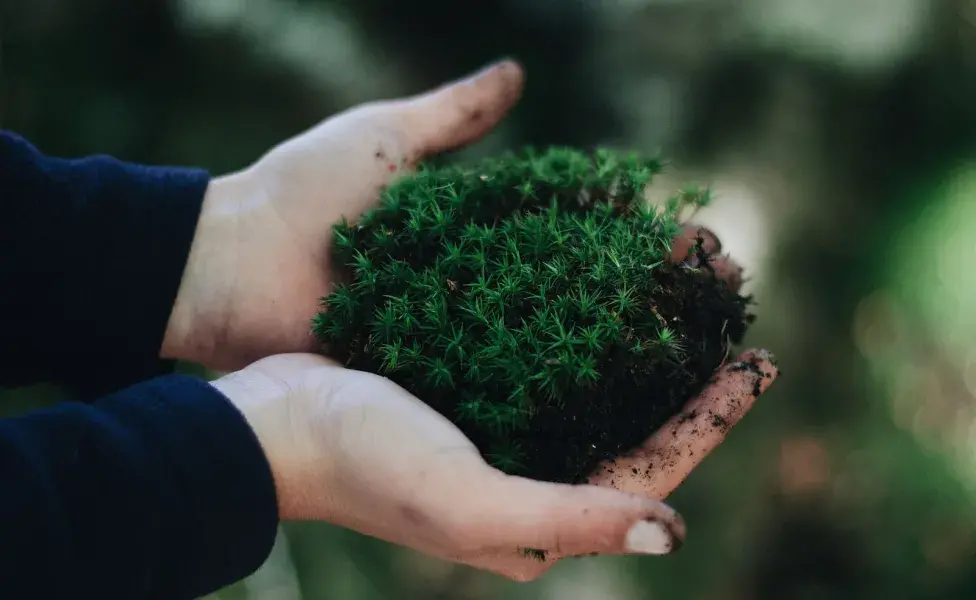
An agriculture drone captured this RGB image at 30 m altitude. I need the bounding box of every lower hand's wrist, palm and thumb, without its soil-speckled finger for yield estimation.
[213,354,684,568]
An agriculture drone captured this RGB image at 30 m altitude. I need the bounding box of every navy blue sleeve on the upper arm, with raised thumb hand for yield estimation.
[0,131,209,399]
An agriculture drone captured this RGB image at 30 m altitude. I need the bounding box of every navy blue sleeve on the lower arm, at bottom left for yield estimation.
[0,375,278,600]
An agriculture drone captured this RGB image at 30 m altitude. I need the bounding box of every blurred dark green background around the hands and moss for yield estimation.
[0,0,976,600]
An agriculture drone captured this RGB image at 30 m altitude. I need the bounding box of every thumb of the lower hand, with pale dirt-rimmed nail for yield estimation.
[471,476,685,556]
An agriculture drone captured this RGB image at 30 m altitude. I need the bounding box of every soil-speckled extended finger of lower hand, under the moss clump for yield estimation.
[589,350,779,499]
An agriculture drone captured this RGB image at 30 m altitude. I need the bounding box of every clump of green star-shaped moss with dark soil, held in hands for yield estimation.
[314,148,751,483]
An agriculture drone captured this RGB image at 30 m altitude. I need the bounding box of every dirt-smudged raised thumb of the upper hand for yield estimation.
[402,60,525,162]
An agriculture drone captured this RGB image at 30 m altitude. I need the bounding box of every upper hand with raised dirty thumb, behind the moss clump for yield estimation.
[161,61,523,371]
